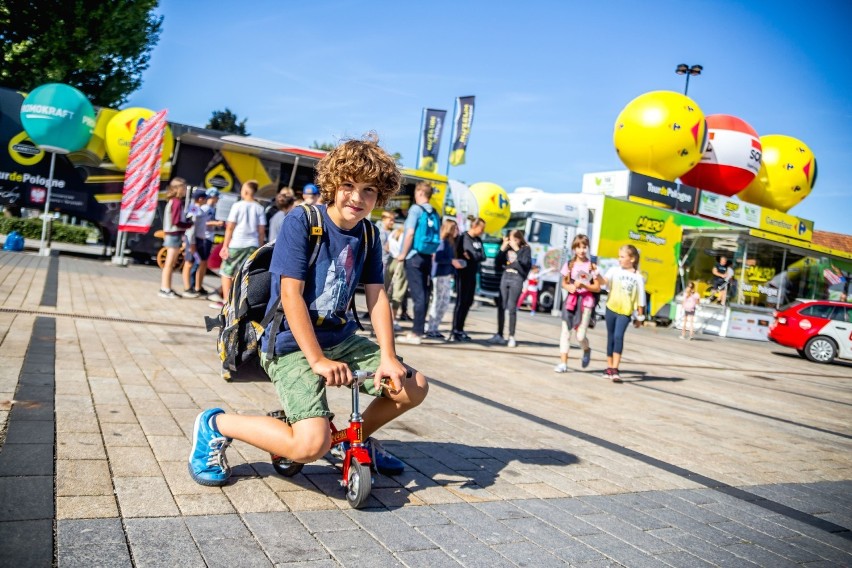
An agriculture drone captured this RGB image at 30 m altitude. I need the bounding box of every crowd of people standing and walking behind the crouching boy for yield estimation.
[159,174,644,382]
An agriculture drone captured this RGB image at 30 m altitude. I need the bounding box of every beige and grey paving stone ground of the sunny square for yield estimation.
[0,253,852,568]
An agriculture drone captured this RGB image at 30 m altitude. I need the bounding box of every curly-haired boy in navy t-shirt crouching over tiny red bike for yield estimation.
[189,137,428,486]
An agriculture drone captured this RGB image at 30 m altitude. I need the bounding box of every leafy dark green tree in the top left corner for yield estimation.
[0,0,163,107]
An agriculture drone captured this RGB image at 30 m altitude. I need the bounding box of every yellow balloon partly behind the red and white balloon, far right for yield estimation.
[737,134,817,213]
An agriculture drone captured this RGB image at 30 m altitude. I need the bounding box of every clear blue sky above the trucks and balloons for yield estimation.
[129,0,852,234]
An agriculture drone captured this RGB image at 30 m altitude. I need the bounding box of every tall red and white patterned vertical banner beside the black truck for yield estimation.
[118,110,166,233]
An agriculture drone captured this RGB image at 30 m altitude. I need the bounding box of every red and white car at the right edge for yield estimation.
[769,300,852,363]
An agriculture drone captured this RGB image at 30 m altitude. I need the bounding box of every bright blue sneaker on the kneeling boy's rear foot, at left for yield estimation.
[188,408,232,487]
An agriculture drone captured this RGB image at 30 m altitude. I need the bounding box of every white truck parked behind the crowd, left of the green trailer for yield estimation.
[503,187,602,311]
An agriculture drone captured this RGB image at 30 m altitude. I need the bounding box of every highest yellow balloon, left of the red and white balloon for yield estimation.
[612,91,707,181]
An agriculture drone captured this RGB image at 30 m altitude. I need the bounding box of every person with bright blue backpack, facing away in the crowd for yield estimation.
[397,181,441,345]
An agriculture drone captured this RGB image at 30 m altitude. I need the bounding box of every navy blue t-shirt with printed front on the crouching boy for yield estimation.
[261,205,384,355]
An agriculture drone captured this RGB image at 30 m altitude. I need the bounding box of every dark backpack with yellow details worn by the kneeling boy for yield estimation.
[204,205,376,381]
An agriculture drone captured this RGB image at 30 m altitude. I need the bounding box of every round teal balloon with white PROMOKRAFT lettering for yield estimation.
[21,83,95,154]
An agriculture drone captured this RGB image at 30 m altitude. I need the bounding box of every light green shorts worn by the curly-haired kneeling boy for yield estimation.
[260,335,402,424]
